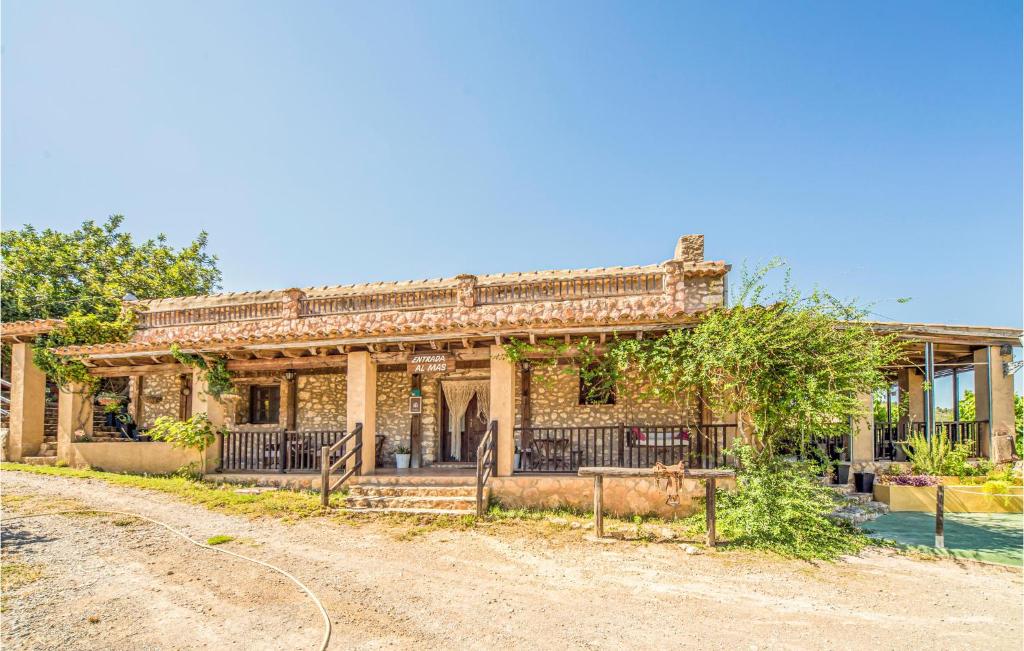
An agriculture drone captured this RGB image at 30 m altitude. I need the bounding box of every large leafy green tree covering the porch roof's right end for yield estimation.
[609,262,903,453]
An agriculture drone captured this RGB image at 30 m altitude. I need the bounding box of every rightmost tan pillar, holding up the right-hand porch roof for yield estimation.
[974,346,1014,463]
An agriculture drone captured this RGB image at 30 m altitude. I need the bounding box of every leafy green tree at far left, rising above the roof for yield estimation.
[0,215,220,386]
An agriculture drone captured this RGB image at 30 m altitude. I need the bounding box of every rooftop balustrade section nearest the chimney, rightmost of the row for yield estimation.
[474,271,665,305]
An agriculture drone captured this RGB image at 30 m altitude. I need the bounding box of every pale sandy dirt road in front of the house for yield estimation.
[0,472,1024,651]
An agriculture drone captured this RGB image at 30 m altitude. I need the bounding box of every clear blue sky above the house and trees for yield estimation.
[2,0,1022,335]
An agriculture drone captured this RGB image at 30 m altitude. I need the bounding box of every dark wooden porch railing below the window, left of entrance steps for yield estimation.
[220,430,345,473]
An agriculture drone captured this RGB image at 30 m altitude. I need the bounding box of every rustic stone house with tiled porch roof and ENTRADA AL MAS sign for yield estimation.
[3,235,1021,512]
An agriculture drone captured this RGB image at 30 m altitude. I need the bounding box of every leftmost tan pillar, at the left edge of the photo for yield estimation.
[7,344,46,462]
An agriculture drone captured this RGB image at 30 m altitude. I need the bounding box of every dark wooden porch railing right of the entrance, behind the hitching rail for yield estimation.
[515,424,736,473]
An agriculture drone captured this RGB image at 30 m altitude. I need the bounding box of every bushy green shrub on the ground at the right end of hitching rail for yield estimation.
[691,445,865,560]
